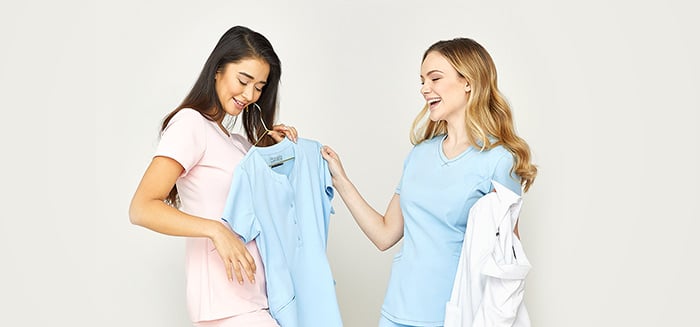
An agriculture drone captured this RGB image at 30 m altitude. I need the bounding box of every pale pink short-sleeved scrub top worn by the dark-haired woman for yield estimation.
[155,109,268,322]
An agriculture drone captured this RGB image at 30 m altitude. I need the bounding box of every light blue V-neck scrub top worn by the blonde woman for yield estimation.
[382,135,521,326]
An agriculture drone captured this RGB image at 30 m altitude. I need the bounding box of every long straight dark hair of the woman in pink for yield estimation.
[161,26,282,207]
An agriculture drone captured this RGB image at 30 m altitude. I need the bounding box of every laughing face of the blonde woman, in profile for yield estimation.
[420,51,471,123]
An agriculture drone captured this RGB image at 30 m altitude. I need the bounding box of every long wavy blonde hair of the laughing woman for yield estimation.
[411,38,537,192]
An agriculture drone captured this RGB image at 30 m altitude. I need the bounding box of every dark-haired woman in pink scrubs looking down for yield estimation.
[129,26,297,326]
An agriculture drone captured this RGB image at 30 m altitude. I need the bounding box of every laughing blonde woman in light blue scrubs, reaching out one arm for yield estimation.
[322,38,537,327]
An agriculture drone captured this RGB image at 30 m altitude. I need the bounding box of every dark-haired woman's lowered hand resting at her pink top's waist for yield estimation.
[211,222,256,285]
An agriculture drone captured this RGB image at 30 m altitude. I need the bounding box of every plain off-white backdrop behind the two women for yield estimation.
[0,0,700,327]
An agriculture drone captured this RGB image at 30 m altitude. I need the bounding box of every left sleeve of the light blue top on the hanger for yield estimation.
[222,165,261,243]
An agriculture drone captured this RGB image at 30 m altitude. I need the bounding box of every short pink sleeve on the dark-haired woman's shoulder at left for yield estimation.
[154,109,207,176]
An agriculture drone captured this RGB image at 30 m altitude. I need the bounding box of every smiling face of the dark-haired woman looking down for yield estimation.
[215,58,270,116]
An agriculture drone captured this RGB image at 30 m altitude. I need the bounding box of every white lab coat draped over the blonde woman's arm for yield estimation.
[445,181,531,327]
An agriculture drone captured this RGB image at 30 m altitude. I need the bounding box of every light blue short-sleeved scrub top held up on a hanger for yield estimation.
[223,138,342,327]
